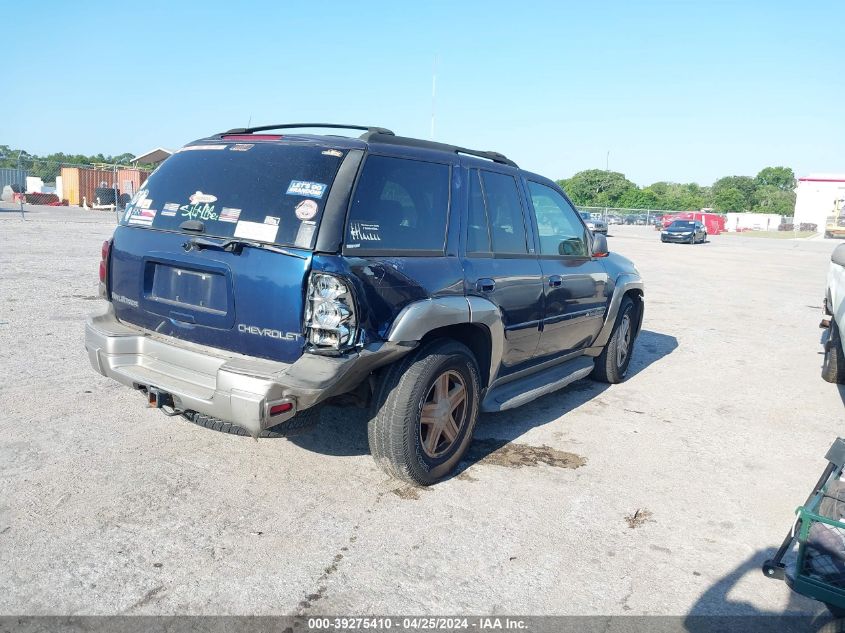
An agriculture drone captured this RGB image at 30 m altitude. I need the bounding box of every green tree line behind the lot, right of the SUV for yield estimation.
[557,167,796,215]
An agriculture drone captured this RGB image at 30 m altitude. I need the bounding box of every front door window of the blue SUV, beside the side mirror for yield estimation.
[528,180,589,257]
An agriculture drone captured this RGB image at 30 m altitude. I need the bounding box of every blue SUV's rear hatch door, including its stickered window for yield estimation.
[109,141,344,362]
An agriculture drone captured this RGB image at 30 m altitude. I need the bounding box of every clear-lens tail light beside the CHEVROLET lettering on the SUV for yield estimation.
[305,273,357,351]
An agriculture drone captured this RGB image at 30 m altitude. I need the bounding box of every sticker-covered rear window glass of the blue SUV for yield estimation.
[121,143,343,248]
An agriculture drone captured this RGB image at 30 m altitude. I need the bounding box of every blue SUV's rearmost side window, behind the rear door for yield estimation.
[344,156,449,255]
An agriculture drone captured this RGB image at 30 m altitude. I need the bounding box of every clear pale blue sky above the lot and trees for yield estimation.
[0,0,845,185]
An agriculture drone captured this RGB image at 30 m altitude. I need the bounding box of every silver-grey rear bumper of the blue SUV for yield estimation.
[85,306,411,436]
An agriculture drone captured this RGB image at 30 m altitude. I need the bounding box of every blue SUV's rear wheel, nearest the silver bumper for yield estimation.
[367,340,480,486]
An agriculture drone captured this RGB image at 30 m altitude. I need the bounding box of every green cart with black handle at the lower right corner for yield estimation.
[763,438,845,618]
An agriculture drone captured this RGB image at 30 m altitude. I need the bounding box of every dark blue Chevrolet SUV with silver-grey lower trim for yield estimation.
[85,124,643,485]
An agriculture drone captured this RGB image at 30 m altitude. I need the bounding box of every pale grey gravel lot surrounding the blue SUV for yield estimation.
[0,205,845,615]
